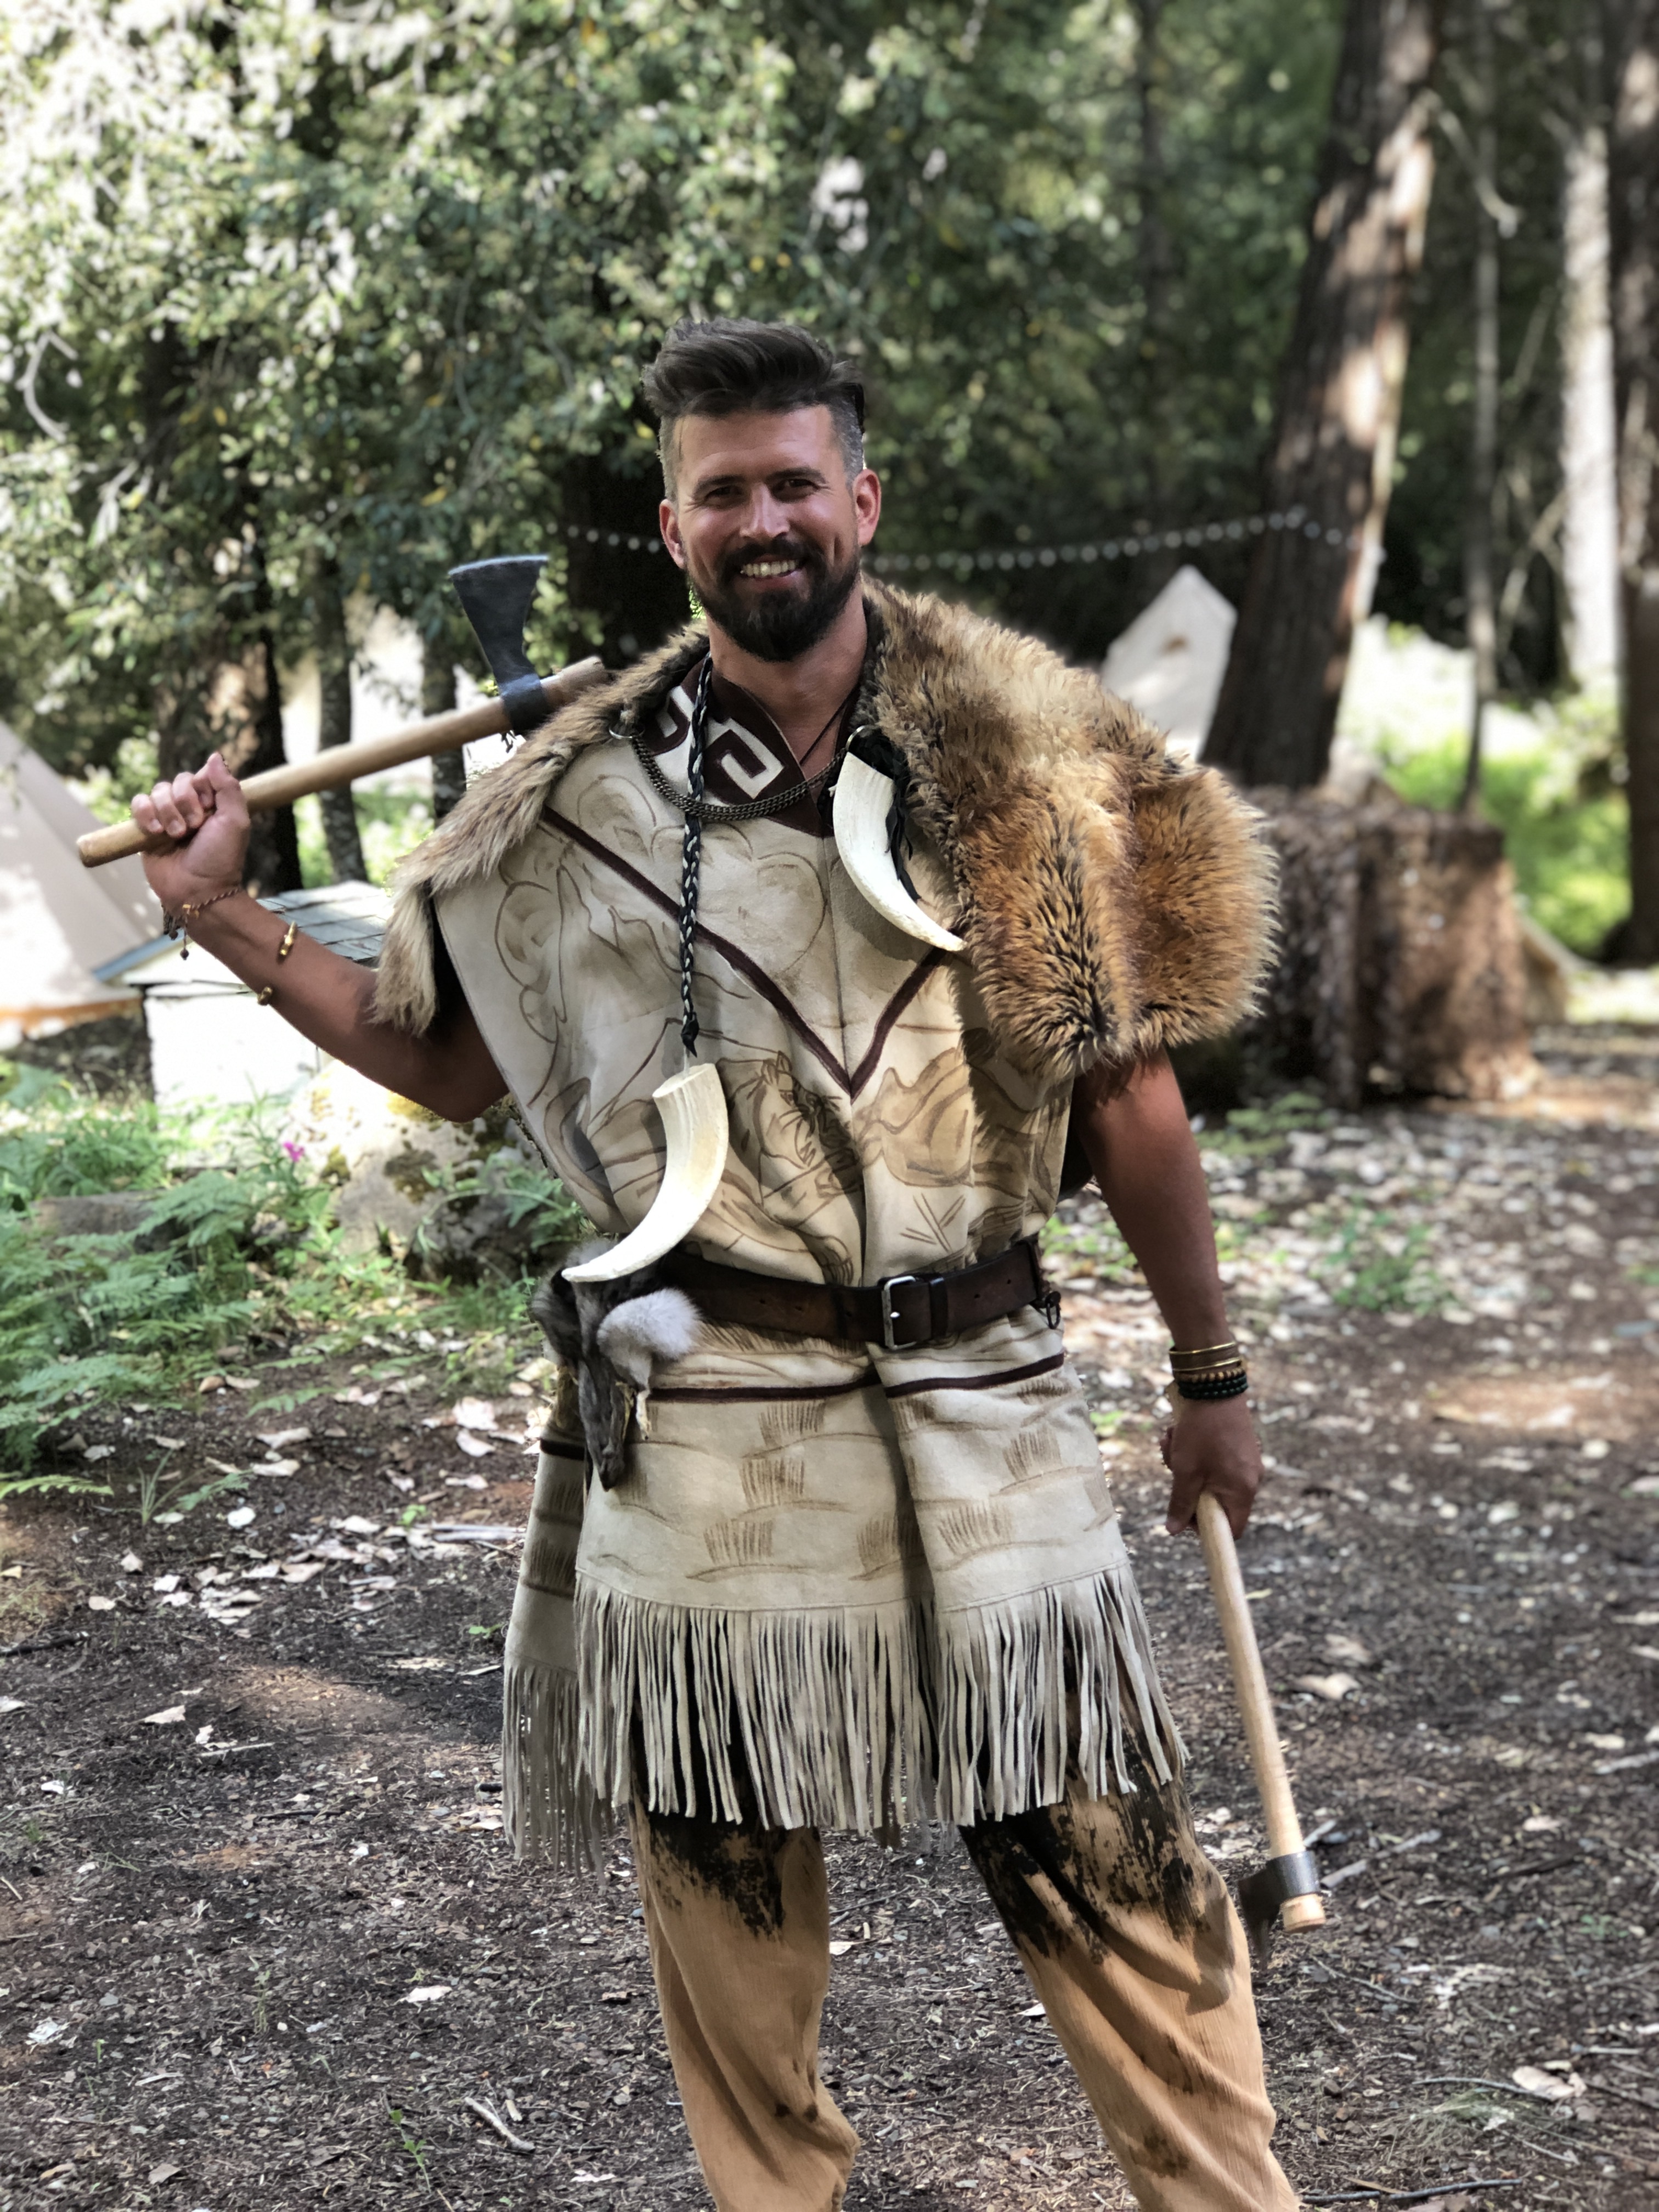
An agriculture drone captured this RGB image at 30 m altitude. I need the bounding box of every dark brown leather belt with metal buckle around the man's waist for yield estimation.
[662,1237,1059,1352]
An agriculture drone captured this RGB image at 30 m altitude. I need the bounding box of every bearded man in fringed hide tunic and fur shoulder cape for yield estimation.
[135,323,1294,2212]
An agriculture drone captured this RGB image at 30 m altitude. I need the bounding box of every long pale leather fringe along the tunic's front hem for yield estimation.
[575,1568,1186,1834]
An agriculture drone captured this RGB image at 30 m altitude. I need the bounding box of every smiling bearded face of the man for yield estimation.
[659,407,881,662]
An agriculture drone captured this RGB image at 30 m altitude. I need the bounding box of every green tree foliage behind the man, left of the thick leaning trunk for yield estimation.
[0,0,1336,770]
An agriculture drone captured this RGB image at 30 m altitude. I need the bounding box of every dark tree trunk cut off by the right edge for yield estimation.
[1606,0,1659,964]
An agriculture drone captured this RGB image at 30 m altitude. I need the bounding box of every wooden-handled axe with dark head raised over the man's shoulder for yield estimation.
[75,553,604,867]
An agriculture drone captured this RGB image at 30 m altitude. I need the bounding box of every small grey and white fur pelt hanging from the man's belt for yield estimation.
[531,1239,703,1491]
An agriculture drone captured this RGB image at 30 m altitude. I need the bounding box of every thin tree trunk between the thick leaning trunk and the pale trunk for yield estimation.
[1460,0,1498,810]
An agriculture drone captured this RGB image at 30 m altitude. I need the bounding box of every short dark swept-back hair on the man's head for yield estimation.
[641,314,865,500]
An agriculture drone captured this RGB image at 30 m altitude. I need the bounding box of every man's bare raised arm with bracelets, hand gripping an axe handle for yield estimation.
[133,754,506,1121]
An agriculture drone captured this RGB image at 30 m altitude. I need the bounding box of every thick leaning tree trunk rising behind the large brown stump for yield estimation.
[1203,0,1440,787]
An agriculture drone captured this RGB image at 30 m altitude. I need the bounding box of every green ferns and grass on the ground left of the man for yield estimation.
[0,1064,582,1477]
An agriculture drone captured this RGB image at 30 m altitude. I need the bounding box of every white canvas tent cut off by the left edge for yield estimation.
[0,723,161,1048]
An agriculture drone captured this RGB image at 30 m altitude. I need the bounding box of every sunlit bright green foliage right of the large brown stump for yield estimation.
[1387,716,1630,958]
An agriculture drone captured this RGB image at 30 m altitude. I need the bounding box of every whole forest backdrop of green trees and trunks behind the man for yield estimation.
[0,0,1659,958]
